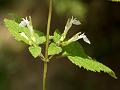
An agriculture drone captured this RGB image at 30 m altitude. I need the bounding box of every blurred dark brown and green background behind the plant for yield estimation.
[0,0,120,90]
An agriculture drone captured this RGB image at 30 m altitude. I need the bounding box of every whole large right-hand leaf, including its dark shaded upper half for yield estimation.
[63,42,117,78]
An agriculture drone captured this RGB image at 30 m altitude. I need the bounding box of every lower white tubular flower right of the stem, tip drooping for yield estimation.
[67,32,91,44]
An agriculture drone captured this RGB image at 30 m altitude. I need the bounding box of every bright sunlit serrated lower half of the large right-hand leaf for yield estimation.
[68,56,117,78]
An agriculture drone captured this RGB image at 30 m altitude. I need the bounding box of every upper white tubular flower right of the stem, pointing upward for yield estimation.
[60,16,81,41]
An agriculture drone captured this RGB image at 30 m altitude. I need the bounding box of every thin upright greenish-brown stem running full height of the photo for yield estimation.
[43,0,52,90]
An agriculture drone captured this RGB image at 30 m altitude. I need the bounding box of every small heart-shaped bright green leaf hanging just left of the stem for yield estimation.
[29,46,41,58]
